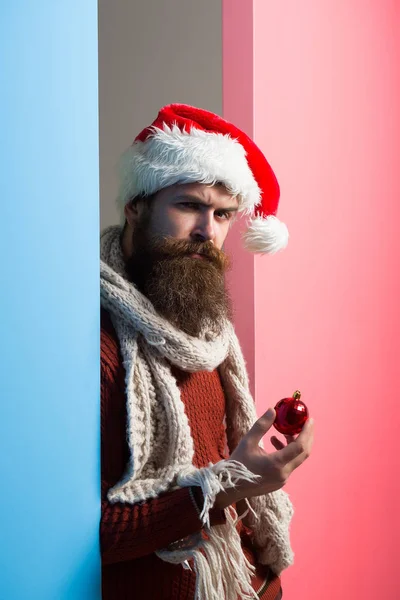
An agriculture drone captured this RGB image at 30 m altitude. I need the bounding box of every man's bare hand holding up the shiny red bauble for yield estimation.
[214,408,314,509]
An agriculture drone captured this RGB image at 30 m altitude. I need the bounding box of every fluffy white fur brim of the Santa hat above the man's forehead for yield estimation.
[117,124,261,213]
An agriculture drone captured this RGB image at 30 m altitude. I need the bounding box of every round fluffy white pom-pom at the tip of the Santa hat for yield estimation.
[243,215,289,254]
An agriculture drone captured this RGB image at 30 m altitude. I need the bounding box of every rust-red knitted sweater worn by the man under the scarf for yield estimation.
[100,310,280,600]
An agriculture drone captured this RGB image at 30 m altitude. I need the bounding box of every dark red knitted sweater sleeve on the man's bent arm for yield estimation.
[100,350,225,565]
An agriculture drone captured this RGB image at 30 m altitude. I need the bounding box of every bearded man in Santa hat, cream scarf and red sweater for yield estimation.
[100,104,313,600]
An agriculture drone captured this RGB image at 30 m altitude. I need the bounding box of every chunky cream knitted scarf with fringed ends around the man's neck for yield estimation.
[101,226,293,600]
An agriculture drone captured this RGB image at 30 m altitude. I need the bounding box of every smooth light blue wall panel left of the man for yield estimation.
[0,0,100,600]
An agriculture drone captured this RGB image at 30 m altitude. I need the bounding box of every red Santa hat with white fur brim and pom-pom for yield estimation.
[118,104,289,254]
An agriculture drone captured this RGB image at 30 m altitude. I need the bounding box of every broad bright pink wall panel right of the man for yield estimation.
[224,0,400,600]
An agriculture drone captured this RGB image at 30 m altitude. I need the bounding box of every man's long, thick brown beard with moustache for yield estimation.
[126,221,232,337]
